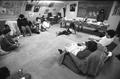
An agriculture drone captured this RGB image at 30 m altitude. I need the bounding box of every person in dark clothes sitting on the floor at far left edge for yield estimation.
[0,28,20,51]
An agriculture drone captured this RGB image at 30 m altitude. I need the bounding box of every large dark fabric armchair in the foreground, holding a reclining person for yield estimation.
[59,42,111,76]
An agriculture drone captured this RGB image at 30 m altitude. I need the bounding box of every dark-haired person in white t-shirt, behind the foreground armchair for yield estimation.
[89,30,116,46]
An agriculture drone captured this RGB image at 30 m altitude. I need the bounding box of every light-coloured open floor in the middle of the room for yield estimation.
[0,25,120,79]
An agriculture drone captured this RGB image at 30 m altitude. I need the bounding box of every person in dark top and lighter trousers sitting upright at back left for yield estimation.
[17,14,32,37]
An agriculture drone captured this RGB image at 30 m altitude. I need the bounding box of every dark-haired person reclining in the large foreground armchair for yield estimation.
[58,41,97,59]
